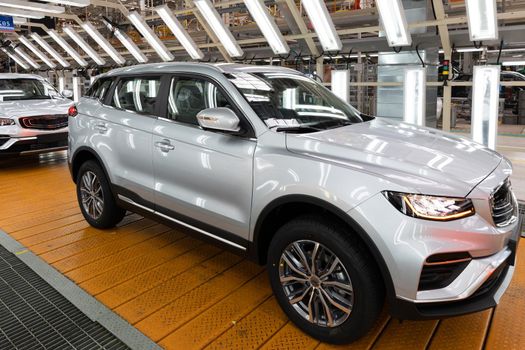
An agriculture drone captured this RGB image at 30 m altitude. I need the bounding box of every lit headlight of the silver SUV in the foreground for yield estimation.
[383,191,476,221]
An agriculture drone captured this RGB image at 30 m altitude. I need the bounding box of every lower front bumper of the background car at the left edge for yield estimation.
[0,132,68,155]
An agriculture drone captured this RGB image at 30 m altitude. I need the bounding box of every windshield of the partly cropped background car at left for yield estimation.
[0,79,61,102]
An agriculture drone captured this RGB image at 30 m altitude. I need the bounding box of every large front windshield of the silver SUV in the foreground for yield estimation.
[227,73,362,132]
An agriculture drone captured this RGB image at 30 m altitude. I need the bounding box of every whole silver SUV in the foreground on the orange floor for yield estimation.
[69,63,521,343]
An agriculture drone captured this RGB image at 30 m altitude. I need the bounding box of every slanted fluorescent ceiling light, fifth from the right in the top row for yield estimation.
[194,0,244,57]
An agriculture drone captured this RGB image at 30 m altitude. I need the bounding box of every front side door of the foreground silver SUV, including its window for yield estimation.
[153,75,256,245]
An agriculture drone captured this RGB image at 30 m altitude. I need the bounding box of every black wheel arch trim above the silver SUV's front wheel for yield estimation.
[252,195,395,300]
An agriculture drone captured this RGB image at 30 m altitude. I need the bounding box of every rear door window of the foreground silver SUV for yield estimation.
[111,77,160,115]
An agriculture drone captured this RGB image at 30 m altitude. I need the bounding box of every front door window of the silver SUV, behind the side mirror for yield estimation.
[168,77,231,125]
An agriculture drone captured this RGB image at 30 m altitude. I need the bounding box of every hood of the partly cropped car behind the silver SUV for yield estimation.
[0,99,73,118]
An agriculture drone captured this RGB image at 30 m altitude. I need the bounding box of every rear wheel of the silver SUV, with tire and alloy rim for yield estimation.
[77,160,126,229]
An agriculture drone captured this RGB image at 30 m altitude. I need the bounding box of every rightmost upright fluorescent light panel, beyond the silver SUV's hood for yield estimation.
[471,66,500,149]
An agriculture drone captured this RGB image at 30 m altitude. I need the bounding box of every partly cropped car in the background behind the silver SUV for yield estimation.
[0,73,75,156]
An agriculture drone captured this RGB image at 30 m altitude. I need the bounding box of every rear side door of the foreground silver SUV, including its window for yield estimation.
[93,76,161,207]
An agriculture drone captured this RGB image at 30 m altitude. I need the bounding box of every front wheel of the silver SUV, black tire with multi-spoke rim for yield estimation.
[268,217,385,344]
